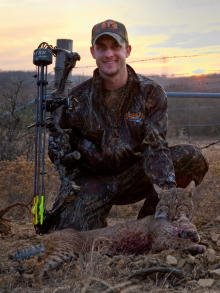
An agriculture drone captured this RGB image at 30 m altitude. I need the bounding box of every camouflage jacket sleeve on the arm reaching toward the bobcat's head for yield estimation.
[143,84,176,188]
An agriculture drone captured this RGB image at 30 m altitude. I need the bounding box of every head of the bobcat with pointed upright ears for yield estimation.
[154,181,195,221]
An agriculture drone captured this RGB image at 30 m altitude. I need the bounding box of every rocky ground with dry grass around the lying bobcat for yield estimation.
[0,142,220,293]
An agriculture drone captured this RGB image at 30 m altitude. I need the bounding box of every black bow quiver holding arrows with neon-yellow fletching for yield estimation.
[32,42,80,225]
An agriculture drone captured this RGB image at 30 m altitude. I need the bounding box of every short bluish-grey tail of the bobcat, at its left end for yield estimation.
[9,244,45,261]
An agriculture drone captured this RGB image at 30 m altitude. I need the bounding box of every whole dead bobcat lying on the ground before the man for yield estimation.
[10,182,205,278]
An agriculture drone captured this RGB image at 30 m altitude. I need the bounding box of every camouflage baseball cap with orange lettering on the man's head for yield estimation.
[92,19,129,45]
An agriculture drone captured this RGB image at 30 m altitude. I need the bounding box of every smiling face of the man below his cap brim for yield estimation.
[90,35,131,77]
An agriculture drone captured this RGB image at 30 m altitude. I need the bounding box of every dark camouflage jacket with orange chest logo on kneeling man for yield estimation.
[49,65,175,186]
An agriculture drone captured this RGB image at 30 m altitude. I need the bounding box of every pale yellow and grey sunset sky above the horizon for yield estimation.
[0,0,220,76]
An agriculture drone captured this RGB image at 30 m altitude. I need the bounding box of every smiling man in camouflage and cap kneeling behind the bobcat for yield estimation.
[39,20,208,233]
